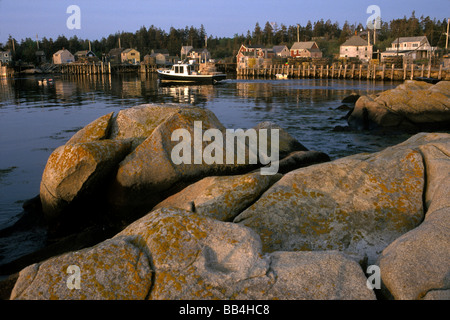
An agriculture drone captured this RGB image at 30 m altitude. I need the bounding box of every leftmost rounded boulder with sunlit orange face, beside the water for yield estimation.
[40,140,130,220]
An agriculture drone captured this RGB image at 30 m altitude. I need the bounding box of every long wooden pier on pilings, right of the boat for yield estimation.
[237,64,450,81]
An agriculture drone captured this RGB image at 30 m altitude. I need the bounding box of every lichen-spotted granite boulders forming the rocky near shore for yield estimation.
[0,82,450,300]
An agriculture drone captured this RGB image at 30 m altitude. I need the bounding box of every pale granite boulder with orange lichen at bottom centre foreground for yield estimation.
[118,208,375,299]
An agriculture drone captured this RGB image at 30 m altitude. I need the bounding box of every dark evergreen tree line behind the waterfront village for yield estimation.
[0,11,447,62]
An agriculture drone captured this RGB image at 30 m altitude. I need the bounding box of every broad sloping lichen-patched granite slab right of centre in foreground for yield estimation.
[234,131,425,263]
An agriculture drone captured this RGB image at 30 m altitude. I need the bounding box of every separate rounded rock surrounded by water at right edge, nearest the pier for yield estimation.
[348,80,450,129]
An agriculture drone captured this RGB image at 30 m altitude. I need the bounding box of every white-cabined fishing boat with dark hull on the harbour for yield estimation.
[158,61,227,84]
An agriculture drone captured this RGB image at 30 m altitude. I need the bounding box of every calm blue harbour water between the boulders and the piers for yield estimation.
[0,75,409,260]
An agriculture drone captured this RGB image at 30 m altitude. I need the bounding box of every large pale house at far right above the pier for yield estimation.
[381,36,437,63]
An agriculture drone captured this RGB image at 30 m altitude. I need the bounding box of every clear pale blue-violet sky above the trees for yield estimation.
[0,0,450,43]
